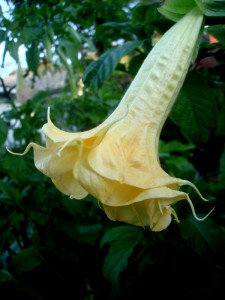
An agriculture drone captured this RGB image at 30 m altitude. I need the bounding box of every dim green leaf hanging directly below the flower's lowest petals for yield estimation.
[100,226,142,289]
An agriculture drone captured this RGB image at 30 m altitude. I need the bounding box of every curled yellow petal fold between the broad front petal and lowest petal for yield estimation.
[76,159,186,206]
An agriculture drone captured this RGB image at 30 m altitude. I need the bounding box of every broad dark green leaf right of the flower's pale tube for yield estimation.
[170,75,218,145]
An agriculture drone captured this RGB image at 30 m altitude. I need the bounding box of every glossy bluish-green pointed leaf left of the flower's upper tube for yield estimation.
[83,41,142,88]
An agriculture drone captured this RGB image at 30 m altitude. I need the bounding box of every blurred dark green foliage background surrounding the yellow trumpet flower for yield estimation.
[0,0,225,300]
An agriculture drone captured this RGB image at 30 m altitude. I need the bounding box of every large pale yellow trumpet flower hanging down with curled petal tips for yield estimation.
[9,8,213,231]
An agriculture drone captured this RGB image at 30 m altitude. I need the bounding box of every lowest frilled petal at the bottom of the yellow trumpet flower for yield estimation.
[103,187,187,231]
